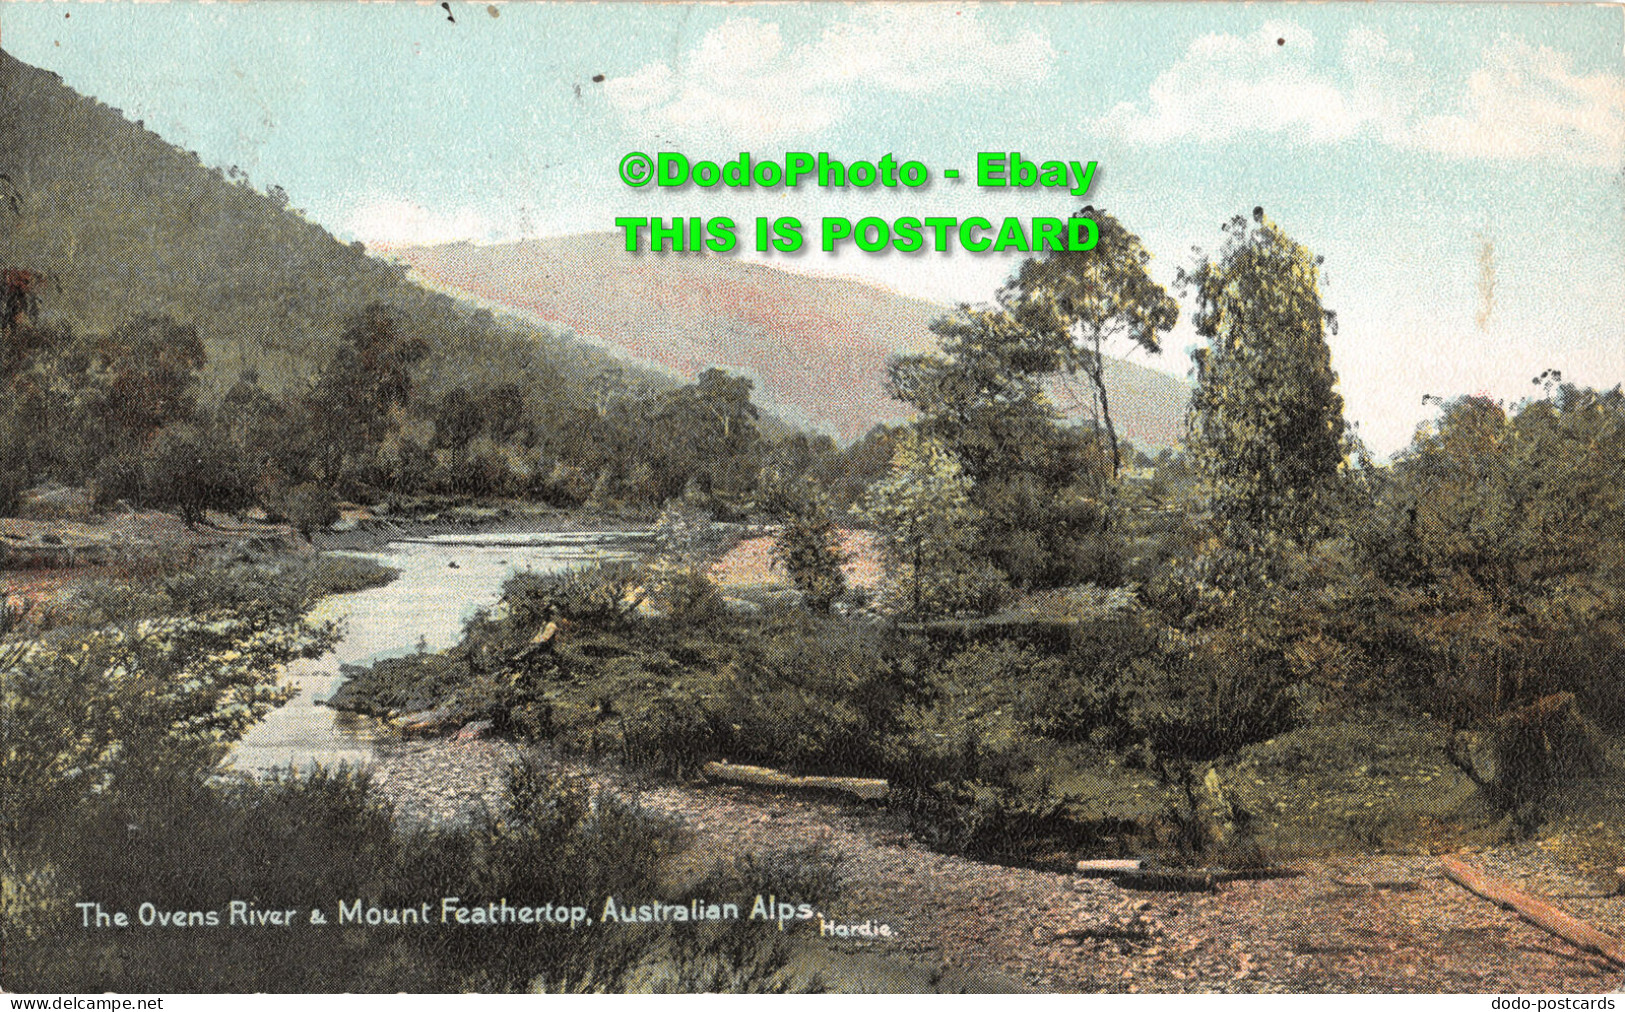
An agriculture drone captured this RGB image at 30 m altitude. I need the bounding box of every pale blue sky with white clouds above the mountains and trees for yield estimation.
[0,0,1625,453]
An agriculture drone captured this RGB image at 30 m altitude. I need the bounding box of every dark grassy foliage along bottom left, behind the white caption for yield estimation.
[3,763,834,993]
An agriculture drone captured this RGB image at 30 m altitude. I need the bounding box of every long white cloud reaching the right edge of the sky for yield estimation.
[1095,23,1625,166]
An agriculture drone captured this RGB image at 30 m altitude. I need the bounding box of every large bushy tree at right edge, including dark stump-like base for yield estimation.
[1355,387,1625,828]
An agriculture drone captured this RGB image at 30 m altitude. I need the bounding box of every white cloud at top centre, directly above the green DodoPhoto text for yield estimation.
[605,5,1055,141]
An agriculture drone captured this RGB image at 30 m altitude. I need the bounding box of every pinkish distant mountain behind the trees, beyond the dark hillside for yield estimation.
[388,232,1190,448]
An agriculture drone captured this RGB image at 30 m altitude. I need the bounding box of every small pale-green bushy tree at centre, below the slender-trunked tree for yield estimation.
[856,430,1001,614]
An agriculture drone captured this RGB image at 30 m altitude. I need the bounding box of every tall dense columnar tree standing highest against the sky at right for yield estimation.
[1180,208,1346,543]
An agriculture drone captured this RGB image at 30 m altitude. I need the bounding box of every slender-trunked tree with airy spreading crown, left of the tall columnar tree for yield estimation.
[999,208,1180,478]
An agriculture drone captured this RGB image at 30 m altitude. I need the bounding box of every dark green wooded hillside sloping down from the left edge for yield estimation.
[0,52,627,401]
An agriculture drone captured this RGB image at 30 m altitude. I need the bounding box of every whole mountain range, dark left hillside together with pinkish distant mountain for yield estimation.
[0,44,1190,448]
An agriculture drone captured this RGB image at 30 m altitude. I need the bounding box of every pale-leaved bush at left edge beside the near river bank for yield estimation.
[0,562,393,846]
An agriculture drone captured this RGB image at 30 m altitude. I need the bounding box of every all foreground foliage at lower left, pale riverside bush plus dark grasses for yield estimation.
[0,557,835,993]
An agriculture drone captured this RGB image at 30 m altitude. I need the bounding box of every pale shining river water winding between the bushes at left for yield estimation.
[229,531,635,770]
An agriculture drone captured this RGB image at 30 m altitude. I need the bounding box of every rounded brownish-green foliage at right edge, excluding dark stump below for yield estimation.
[1365,388,1625,720]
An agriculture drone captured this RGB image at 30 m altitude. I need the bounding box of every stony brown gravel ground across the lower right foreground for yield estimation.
[368,730,1625,993]
